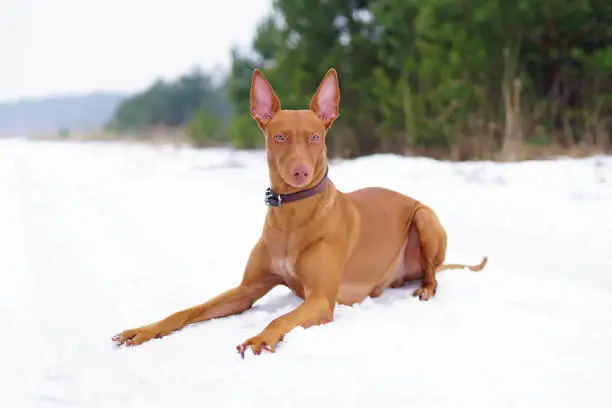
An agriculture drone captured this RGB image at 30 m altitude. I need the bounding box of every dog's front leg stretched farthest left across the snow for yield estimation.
[113,242,280,345]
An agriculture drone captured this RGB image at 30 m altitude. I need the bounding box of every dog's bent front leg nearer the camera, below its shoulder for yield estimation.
[237,243,342,356]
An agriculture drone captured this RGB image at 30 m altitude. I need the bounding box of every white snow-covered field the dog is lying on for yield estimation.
[0,140,612,408]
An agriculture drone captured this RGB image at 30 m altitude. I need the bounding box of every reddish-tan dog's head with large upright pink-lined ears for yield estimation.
[251,69,340,193]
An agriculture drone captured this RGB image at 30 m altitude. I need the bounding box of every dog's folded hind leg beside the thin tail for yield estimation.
[412,206,447,300]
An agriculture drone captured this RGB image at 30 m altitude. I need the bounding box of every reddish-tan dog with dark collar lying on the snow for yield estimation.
[113,69,487,356]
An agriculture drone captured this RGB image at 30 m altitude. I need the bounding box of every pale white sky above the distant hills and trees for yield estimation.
[0,0,271,101]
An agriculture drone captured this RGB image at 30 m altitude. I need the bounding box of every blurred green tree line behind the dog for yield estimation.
[111,0,612,160]
